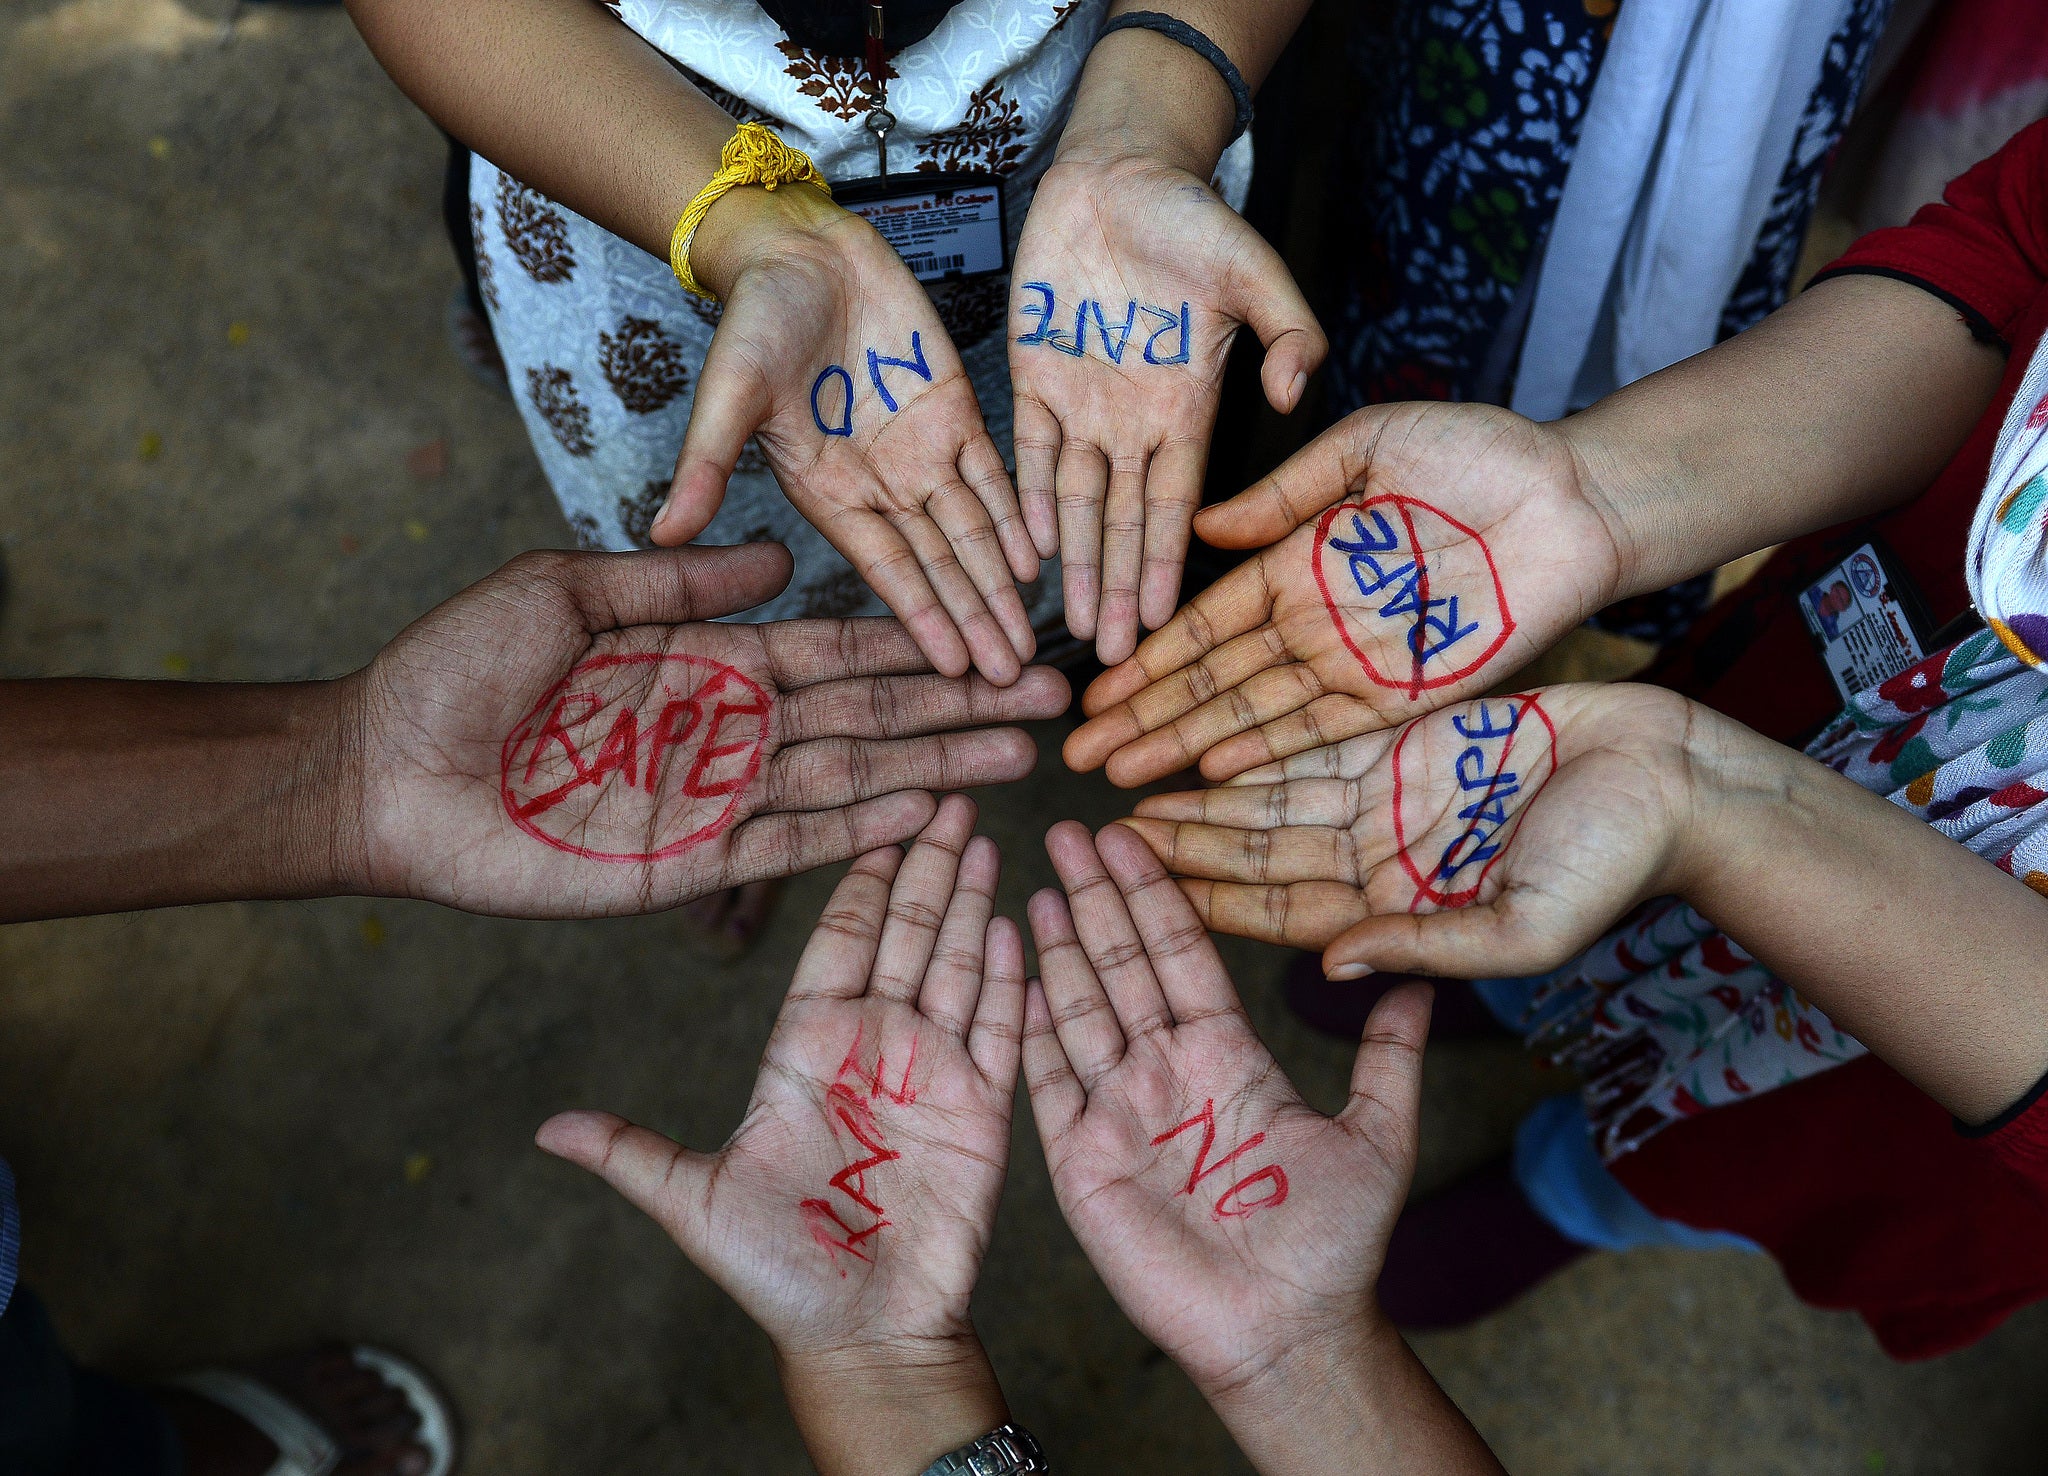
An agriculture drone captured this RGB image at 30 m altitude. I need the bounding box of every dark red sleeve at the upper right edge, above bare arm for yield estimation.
[1812,119,2048,346]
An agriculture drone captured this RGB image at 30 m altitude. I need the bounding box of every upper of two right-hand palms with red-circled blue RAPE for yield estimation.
[1065,405,1620,786]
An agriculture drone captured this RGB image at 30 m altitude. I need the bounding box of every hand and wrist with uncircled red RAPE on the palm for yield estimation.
[539,796,1024,1472]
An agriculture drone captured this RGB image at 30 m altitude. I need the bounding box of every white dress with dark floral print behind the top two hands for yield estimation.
[469,0,1251,631]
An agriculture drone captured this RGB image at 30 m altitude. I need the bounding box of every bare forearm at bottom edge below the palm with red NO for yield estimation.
[1210,1316,1501,1476]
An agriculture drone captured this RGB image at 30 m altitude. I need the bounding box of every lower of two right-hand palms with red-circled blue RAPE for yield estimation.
[1126,686,1700,979]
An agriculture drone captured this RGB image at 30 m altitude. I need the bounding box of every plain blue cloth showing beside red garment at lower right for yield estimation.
[1473,979,1761,1251]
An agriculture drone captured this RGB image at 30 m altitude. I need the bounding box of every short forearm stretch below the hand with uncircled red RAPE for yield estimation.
[776,1333,1010,1476]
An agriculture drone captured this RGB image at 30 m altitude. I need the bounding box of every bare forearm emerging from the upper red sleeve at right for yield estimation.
[1561,276,2005,598]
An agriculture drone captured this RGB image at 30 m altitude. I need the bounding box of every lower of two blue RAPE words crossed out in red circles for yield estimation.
[1393,696,1556,911]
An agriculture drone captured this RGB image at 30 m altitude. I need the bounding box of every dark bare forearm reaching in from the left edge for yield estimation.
[0,682,360,921]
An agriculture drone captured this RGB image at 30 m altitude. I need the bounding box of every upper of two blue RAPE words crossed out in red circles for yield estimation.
[1309,495,1516,698]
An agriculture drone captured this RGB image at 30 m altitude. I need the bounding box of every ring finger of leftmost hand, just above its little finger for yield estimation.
[760,729,1038,813]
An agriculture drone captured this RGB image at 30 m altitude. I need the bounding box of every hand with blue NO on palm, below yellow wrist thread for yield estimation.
[653,186,1038,686]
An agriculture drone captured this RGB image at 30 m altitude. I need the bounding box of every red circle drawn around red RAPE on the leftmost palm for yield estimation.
[498,651,774,862]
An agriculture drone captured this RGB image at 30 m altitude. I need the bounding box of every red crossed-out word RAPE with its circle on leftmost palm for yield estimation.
[498,653,774,862]
